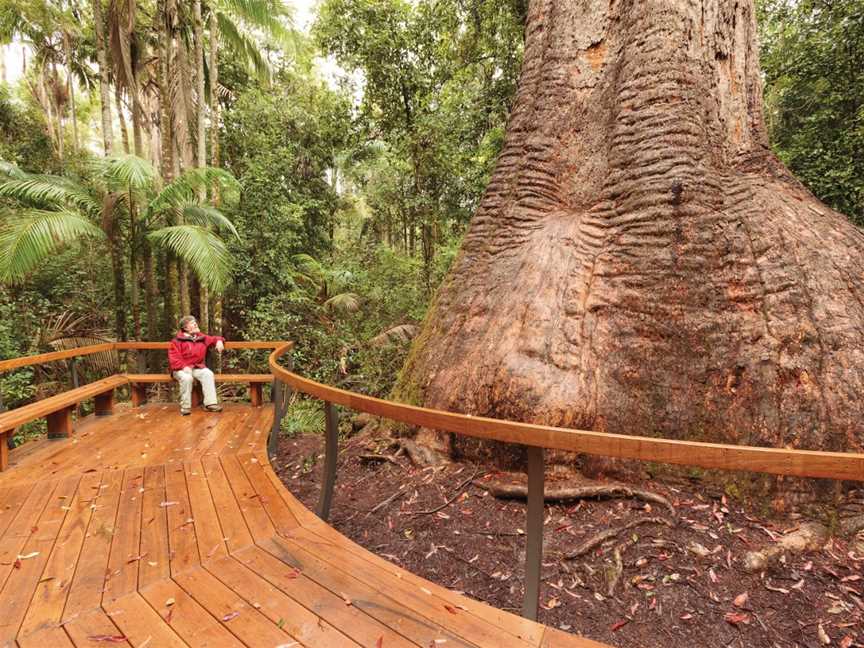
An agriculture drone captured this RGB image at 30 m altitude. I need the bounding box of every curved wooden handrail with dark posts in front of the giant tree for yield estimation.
[270,344,864,620]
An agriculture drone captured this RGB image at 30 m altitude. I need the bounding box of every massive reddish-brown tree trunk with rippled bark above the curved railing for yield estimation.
[395,0,864,452]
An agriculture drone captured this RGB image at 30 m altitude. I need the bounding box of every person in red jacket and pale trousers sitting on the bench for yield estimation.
[168,315,225,416]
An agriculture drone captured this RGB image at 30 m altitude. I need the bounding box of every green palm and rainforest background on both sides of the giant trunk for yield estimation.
[0,0,864,416]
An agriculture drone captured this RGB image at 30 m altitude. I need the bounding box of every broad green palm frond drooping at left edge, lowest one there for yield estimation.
[0,209,104,283]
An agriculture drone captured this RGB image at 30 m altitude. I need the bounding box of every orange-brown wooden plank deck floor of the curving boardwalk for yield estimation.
[0,404,602,648]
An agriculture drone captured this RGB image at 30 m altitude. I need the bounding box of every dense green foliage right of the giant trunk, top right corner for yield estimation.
[758,0,864,226]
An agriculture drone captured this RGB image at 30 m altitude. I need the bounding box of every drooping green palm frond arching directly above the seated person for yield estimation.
[147,225,232,294]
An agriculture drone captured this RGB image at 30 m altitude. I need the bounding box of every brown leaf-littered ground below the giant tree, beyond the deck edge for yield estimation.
[273,426,864,648]
